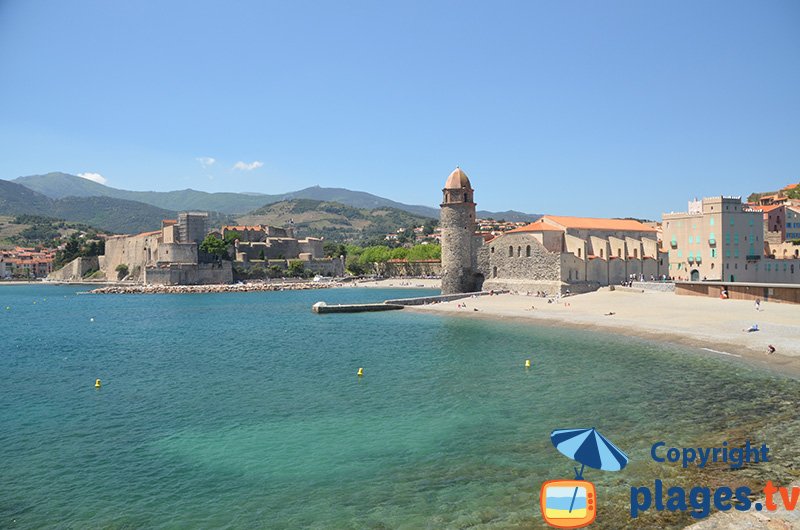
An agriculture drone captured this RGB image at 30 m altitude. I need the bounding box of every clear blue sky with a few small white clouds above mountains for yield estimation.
[0,0,800,219]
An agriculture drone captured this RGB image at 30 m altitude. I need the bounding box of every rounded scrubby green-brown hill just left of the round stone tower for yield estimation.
[237,199,433,241]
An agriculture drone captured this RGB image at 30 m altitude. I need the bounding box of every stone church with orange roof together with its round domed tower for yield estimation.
[440,168,669,294]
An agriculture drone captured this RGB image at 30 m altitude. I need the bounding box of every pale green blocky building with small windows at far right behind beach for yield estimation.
[662,197,800,283]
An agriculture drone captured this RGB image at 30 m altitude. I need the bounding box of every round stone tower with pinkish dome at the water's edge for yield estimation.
[439,167,477,294]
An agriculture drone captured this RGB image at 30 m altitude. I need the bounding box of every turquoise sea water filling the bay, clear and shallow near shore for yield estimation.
[0,286,800,528]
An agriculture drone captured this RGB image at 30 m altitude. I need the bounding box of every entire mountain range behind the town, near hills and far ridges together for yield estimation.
[0,173,539,237]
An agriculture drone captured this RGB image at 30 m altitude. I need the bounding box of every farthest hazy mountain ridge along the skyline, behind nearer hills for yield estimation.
[12,173,539,221]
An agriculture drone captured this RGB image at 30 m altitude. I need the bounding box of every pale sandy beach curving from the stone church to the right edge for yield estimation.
[407,289,800,377]
